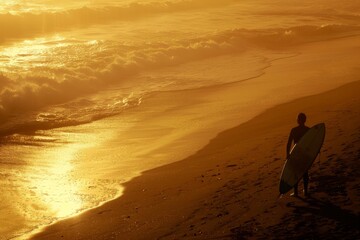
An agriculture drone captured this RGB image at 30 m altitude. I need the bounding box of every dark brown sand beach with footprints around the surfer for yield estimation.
[34,79,360,239]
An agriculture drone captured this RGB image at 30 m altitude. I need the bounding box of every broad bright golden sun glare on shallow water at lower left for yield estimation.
[26,123,118,219]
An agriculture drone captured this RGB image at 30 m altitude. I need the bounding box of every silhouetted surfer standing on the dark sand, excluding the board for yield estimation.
[286,113,310,197]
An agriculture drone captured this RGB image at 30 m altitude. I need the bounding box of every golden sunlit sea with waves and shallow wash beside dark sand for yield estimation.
[0,0,360,239]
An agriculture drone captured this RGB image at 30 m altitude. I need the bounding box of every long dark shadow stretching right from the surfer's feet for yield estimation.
[290,197,360,229]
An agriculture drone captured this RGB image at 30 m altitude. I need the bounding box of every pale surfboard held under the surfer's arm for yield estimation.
[279,123,325,194]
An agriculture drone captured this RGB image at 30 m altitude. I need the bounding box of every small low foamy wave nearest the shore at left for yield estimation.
[0,88,142,137]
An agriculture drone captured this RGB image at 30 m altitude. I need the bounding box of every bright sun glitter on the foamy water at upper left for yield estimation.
[0,34,104,78]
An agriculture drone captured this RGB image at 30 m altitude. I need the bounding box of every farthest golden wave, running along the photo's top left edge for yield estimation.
[0,0,236,42]
